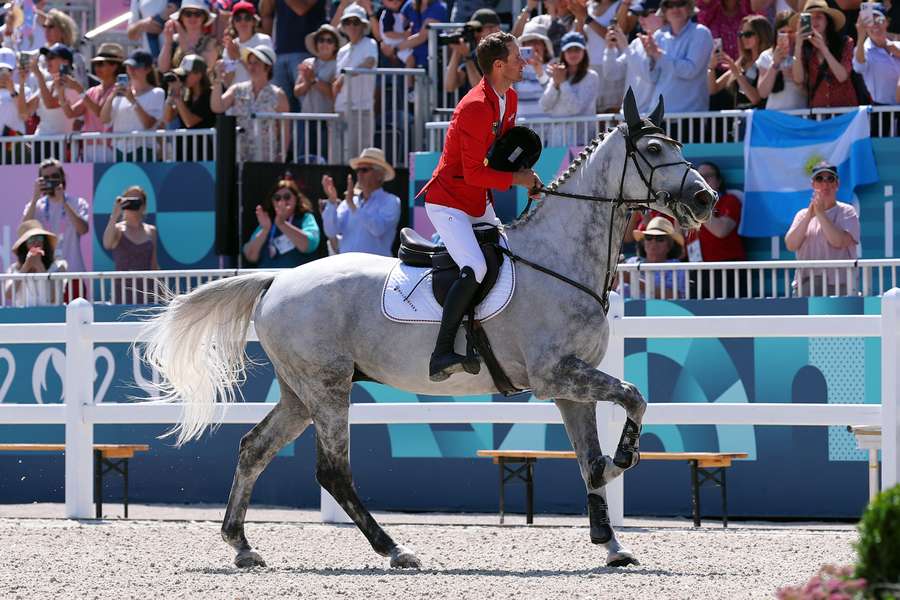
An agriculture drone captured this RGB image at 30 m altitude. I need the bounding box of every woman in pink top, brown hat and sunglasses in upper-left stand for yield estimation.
[66,43,125,162]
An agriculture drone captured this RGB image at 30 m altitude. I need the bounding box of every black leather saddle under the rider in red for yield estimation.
[397,223,504,308]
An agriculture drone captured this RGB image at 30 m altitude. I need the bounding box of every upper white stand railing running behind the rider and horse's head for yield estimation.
[425,106,900,152]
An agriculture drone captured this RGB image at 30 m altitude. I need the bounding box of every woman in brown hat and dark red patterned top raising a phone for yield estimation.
[791,0,859,108]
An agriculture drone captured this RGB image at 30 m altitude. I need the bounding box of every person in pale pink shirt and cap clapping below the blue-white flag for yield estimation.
[784,162,859,296]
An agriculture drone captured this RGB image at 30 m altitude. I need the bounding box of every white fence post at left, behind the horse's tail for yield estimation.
[63,298,94,519]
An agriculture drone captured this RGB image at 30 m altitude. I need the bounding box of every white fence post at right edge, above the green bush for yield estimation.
[881,288,900,490]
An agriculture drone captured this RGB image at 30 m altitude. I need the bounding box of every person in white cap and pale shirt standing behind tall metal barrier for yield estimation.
[334,4,378,162]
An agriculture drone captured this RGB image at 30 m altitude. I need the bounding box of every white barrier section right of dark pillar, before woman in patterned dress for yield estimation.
[245,113,343,165]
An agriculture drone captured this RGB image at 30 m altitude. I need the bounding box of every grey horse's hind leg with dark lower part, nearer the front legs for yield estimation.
[314,380,422,569]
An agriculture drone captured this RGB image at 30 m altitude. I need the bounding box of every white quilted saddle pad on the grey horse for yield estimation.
[381,235,516,323]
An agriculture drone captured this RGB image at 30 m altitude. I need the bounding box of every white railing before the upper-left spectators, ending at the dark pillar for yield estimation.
[0,129,216,165]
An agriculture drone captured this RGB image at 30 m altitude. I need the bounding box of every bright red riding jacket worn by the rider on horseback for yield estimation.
[419,78,518,217]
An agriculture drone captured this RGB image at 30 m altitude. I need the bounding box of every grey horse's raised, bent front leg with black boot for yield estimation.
[549,356,647,474]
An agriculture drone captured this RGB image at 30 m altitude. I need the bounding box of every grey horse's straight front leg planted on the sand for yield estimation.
[555,399,638,567]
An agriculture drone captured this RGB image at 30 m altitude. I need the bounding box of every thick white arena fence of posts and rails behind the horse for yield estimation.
[0,289,900,524]
